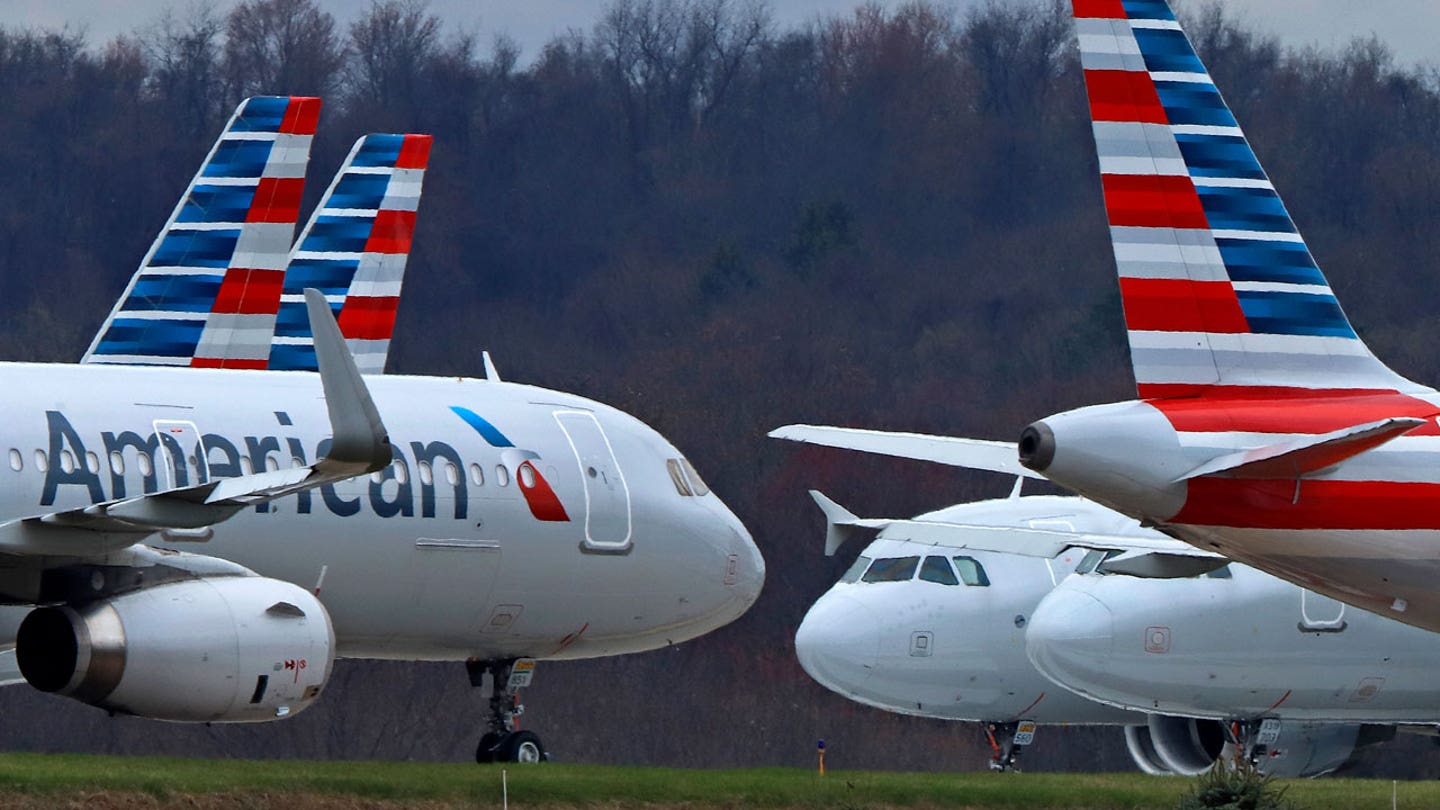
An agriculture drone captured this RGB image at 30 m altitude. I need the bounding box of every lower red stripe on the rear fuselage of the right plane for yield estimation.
[1168,479,1440,530]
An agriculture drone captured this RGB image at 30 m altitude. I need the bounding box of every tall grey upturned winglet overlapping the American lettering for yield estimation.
[305,287,393,476]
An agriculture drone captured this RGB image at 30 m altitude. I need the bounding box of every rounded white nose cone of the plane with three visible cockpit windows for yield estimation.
[795,594,880,695]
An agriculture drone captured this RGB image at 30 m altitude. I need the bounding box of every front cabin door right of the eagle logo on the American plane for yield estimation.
[554,411,631,552]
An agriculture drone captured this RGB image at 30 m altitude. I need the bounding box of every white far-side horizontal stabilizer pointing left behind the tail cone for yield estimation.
[769,425,1044,480]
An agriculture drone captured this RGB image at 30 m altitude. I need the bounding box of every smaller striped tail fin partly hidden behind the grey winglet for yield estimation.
[269,135,431,373]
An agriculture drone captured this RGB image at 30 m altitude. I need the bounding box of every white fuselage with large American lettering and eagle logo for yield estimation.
[0,363,765,660]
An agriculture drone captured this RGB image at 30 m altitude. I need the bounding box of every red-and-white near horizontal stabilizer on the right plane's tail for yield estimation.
[1175,417,1426,483]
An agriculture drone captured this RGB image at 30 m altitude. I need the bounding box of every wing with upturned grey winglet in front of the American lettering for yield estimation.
[0,290,393,555]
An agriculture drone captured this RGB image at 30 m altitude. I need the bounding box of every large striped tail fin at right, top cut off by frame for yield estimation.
[1073,0,1420,398]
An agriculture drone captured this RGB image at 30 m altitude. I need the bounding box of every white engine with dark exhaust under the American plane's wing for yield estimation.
[16,577,336,722]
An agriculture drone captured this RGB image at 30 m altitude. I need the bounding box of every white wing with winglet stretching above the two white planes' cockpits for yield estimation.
[811,490,1228,578]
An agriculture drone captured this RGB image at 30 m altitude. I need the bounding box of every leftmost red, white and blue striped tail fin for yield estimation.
[81,97,320,369]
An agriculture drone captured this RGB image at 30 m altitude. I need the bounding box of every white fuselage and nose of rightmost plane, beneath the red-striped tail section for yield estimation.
[1027,564,1440,724]
